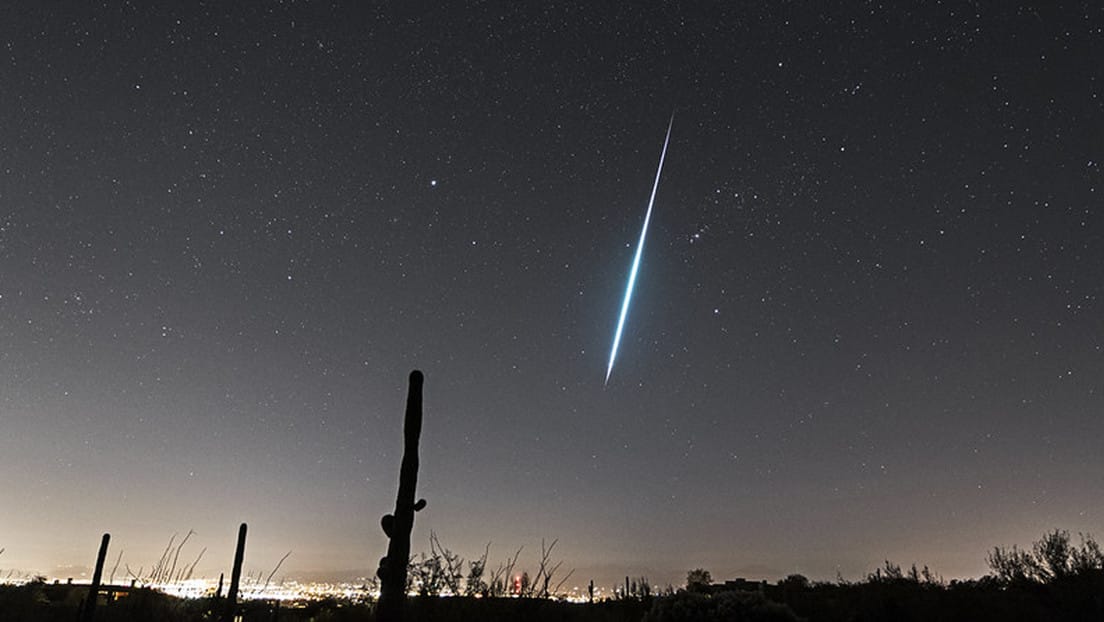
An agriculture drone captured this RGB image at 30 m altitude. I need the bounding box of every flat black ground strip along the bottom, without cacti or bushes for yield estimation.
[0,571,1104,622]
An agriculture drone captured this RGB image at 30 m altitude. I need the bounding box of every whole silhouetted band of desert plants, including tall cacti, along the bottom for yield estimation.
[0,371,1104,622]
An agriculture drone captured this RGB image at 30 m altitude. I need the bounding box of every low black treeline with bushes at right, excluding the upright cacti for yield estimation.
[0,530,1104,622]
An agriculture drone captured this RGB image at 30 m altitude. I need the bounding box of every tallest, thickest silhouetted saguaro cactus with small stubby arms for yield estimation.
[376,369,425,622]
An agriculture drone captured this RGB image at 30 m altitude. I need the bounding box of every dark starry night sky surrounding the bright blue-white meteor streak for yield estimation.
[0,1,1104,584]
